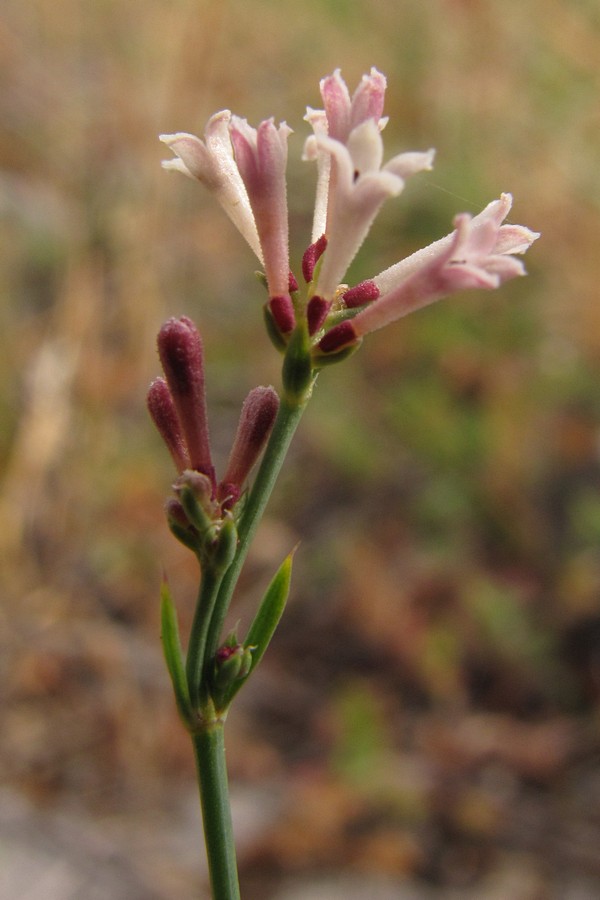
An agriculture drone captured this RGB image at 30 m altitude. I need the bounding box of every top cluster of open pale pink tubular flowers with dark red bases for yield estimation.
[161,69,539,368]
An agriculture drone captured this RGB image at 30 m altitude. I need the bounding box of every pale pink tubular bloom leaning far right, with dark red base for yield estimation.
[319,194,539,352]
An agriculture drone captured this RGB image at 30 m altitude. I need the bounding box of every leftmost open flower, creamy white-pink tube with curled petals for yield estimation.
[160,109,262,262]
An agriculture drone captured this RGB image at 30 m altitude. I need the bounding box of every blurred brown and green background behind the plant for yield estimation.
[0,0,600,900]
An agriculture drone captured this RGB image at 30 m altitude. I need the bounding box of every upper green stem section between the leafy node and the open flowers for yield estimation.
[206,397,308,659]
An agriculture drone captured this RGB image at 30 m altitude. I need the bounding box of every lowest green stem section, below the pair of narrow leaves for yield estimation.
[192,721,240,900]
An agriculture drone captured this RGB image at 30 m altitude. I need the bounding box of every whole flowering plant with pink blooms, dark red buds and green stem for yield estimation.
[148,69,539,900]
